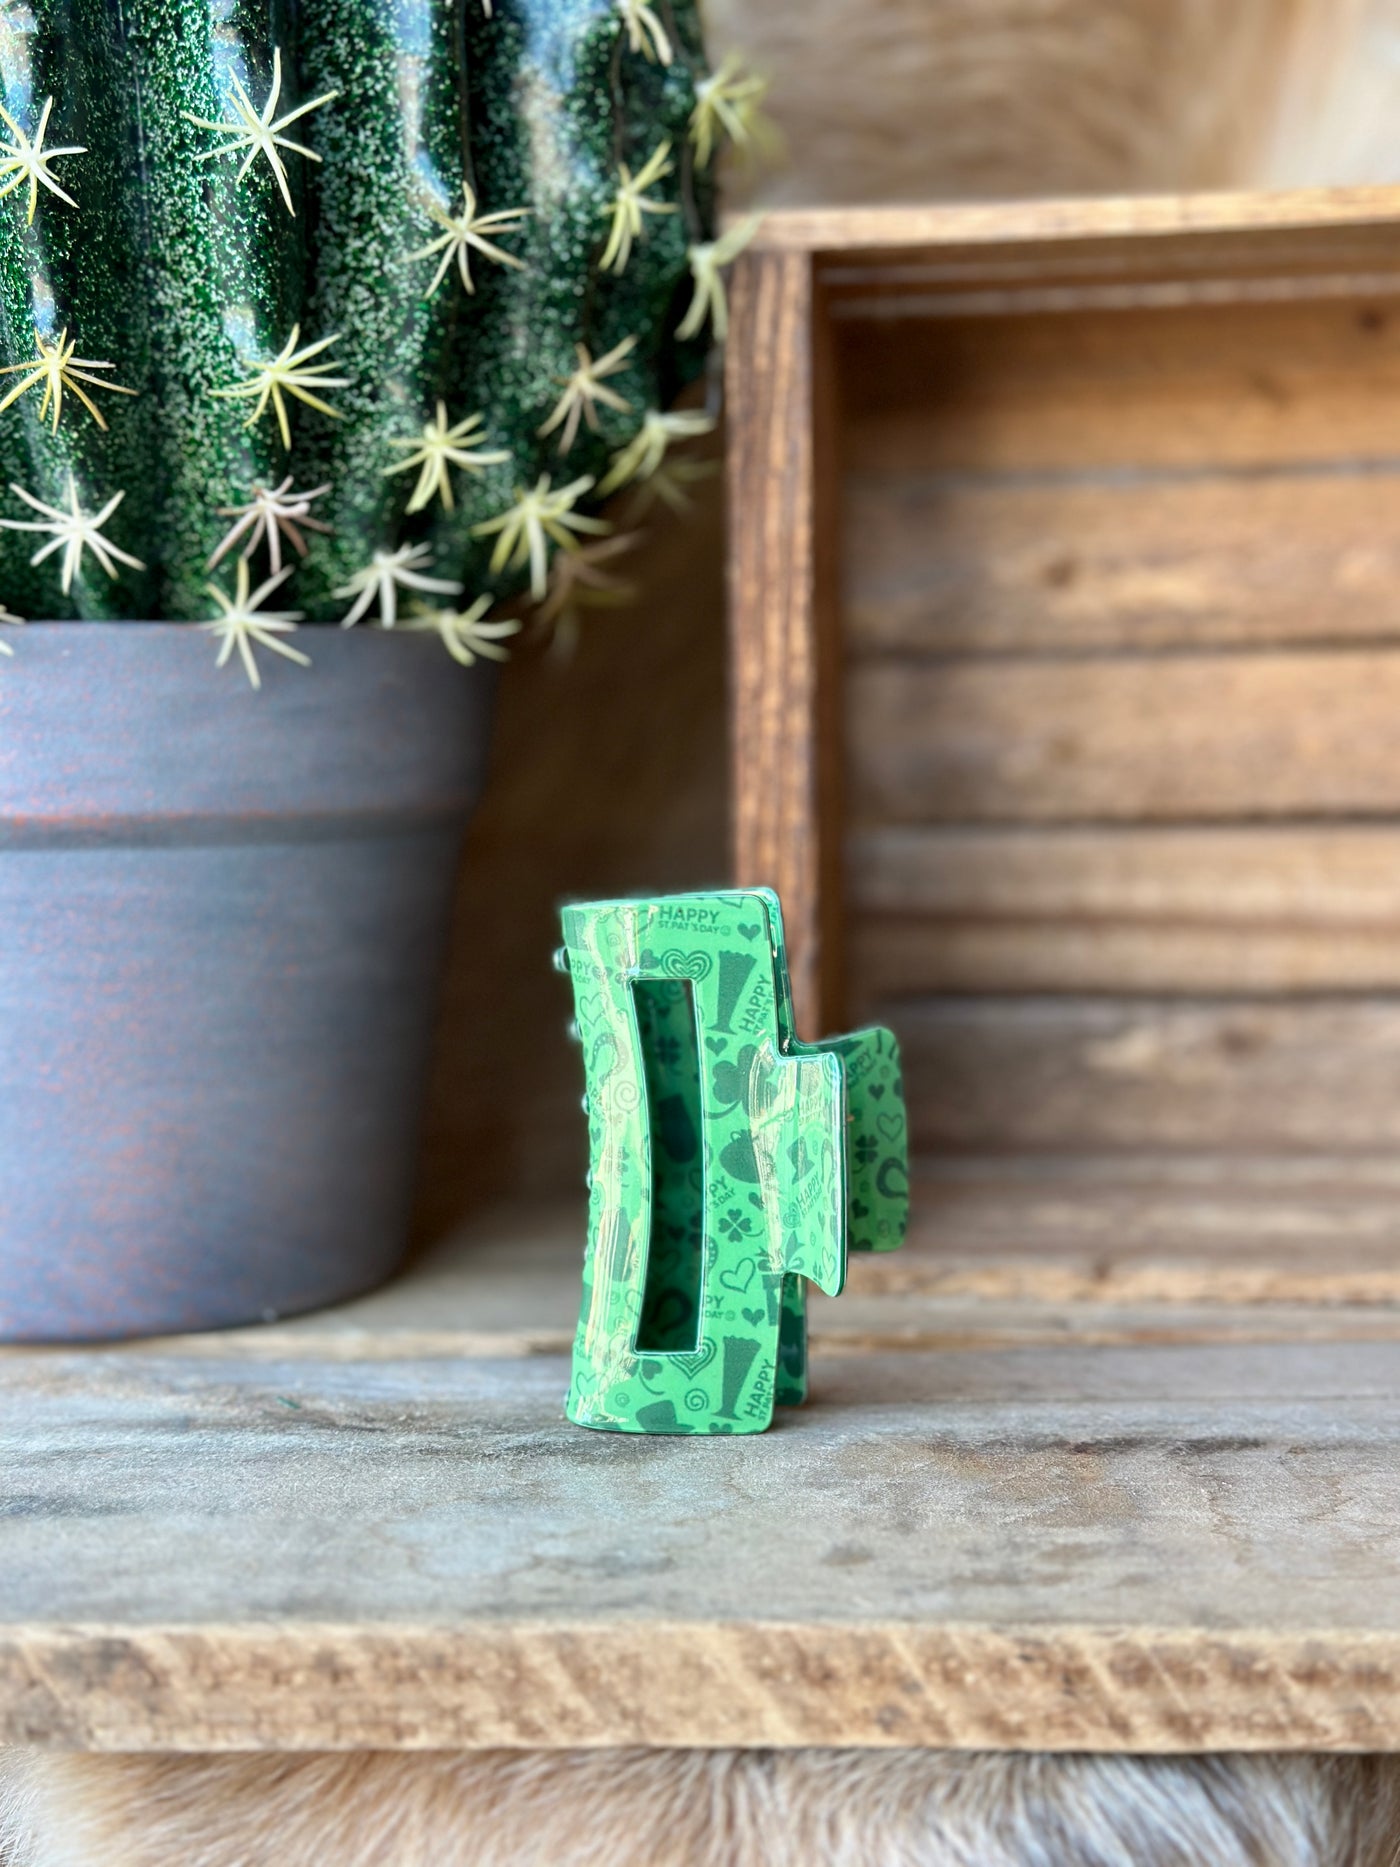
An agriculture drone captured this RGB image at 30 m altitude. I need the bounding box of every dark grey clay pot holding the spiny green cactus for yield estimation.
[0,624,491,1342]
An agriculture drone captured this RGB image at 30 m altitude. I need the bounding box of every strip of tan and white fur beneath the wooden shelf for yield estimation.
[0,1751,1400,1867]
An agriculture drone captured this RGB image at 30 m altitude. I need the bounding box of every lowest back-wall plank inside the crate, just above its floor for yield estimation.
[883,997,1400,1154]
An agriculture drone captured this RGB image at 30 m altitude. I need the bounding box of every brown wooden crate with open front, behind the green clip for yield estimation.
[730,189,1400,1254]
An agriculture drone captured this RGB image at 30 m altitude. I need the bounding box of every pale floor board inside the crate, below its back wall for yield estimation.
[851,1154,1400,1306]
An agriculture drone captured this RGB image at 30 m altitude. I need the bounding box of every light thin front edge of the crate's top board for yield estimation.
[732,183,1400,258]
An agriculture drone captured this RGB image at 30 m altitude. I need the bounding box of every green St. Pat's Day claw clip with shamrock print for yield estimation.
[556,889,909,1434]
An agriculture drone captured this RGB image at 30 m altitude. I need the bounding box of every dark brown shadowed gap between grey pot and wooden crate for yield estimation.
[418,480,728,1238]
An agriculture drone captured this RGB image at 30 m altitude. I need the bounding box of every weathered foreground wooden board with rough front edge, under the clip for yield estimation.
[10,1342,1400,1751]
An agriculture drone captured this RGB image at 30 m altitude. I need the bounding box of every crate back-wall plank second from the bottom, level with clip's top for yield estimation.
[846,825,1400,1004]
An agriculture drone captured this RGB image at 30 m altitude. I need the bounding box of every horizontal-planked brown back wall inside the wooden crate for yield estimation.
[842,280,1400,1154]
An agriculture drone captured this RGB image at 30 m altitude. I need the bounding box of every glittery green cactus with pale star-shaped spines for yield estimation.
[0,0,762,685]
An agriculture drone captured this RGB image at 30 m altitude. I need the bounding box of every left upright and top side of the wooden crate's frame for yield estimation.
[728,187,1400,1034]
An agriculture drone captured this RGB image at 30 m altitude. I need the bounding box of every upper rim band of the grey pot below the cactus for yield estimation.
[0,622,495,825]
